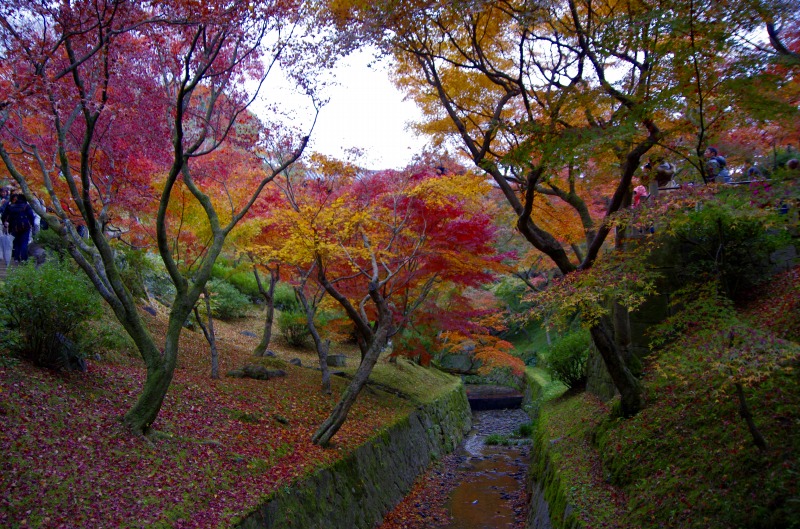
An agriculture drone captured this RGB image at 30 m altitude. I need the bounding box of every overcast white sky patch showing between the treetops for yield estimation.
[260,51,426,169]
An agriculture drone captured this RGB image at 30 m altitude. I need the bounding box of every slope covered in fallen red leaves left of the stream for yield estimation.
[0,306,410,528]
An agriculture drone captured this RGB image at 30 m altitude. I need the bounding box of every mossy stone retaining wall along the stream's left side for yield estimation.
[237,384,472,529]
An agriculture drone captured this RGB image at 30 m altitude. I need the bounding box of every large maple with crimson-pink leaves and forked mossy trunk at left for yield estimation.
[0,0,318,432]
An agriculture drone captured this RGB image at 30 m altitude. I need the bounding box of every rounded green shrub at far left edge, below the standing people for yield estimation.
[0,260,103,369]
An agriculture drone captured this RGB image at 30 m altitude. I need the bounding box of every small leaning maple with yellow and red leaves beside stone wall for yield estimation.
[253,162,500,445]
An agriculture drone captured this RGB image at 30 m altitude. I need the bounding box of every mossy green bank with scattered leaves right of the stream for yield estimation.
[538,270,800,529]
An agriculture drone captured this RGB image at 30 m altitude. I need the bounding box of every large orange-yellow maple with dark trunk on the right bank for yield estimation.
[332,0,796,415]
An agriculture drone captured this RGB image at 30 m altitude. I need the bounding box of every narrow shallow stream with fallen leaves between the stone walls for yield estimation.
[380,409,530,529]
